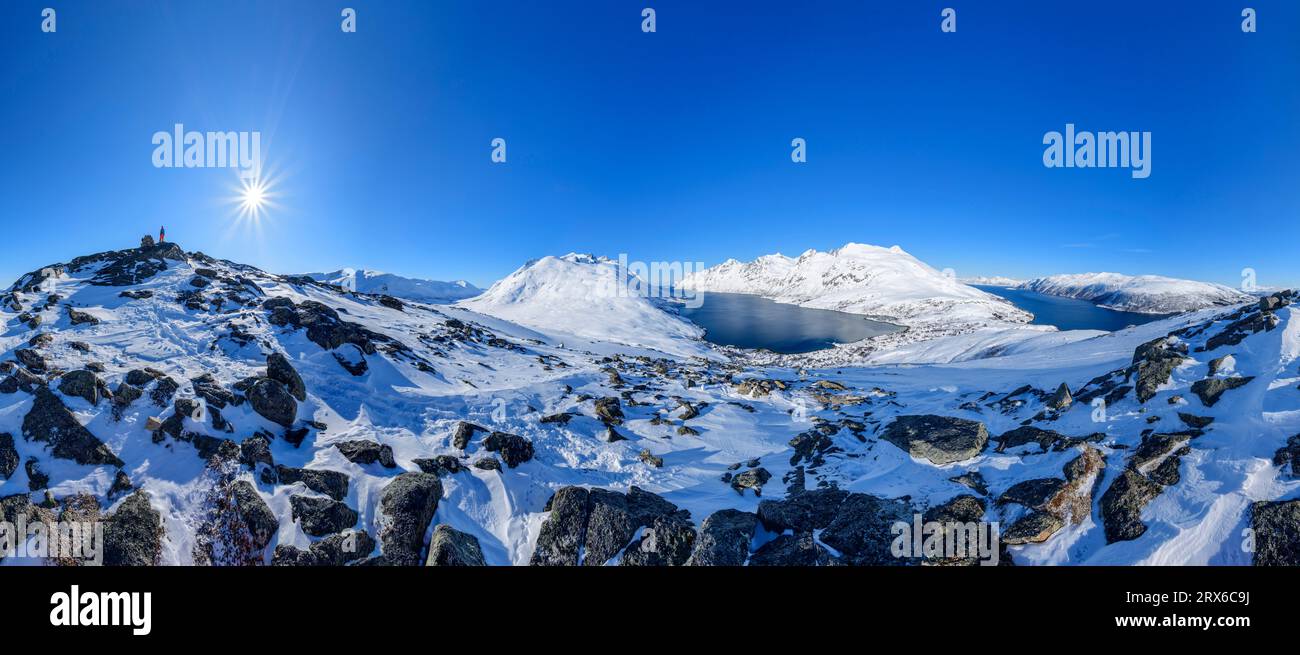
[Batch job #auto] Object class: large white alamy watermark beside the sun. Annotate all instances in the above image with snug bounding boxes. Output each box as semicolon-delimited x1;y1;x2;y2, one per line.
152;123;261;179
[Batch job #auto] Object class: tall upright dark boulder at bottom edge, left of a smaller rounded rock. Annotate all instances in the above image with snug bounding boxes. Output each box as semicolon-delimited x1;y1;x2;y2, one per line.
380;473;442;567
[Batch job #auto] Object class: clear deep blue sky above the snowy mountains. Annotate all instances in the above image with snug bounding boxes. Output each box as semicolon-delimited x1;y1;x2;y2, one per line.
0;0;1300;286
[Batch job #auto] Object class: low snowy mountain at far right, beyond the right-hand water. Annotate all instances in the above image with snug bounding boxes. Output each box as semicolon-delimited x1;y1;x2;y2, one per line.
1017;273;1255;315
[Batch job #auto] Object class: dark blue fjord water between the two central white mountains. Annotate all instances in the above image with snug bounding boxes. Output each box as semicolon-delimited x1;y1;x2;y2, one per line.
681;292;902;353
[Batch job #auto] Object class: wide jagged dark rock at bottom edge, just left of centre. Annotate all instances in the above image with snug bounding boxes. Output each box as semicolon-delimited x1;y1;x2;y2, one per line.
529;486;689;567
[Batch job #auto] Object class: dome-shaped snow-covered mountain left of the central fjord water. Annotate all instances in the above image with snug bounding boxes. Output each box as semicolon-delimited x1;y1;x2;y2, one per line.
460;253;706;355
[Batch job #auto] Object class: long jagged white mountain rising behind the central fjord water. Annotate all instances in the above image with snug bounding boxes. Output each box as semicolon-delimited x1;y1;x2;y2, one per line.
683;243;1032;333
